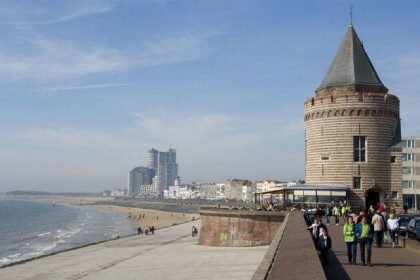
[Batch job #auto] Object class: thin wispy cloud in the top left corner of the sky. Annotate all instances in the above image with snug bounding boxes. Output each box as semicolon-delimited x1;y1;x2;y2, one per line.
0;0;117;25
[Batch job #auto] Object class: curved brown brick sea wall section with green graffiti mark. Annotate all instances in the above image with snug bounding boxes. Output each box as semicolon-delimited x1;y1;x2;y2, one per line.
198;208;286;247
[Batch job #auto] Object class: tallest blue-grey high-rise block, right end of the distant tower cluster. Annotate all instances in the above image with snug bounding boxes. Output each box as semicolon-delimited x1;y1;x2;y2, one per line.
154;149;178;197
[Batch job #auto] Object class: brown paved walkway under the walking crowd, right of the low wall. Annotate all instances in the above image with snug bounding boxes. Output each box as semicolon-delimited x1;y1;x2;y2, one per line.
324;219;420;280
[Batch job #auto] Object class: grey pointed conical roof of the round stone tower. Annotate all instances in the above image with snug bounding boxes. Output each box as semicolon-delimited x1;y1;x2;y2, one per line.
317;25;385;91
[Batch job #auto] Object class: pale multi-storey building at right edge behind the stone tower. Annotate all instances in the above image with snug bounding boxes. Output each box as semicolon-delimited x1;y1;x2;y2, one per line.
401;137;420;210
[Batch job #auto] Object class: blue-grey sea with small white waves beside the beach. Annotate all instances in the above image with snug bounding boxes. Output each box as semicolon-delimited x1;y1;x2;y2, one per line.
0;200;137;267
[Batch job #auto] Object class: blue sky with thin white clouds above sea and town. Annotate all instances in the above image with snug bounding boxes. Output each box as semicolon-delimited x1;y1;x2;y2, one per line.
0;0;420;192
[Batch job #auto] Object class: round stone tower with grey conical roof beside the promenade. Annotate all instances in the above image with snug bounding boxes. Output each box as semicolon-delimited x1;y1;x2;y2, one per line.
304;25;402;209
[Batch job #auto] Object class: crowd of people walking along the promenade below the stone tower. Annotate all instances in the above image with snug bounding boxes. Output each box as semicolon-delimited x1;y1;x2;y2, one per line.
308;205;399;266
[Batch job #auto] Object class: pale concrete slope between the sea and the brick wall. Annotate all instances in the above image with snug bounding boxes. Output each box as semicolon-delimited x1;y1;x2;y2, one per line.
0;220;268;280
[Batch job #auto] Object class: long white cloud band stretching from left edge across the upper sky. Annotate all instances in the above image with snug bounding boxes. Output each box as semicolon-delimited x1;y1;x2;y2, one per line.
0;33;217;82
